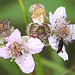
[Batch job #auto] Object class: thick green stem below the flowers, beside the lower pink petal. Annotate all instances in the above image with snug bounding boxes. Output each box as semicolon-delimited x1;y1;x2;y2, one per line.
34;54;44;75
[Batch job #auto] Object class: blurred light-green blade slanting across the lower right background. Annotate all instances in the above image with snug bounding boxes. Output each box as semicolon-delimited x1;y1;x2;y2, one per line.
41;58;75;75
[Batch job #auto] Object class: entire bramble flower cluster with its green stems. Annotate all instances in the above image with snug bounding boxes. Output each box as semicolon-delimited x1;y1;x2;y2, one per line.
0;0;75;75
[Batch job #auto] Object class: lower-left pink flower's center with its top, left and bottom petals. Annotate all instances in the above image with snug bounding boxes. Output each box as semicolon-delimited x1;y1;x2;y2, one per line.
0;29;34;73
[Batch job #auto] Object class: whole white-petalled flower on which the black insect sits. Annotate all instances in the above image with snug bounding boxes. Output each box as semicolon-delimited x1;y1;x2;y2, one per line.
48;7;75;61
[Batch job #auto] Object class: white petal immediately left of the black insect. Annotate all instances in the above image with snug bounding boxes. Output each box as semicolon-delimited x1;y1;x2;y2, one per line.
48;36;58;51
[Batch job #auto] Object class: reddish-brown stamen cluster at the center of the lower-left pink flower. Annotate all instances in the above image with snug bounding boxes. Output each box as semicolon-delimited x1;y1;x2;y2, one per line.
9;42;26;58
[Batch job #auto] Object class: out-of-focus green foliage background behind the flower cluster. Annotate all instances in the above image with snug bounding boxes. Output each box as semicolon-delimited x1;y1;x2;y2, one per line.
0;0;75;75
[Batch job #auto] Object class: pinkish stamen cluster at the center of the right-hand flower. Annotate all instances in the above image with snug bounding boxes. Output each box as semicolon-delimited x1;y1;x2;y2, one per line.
55;18;70;39
